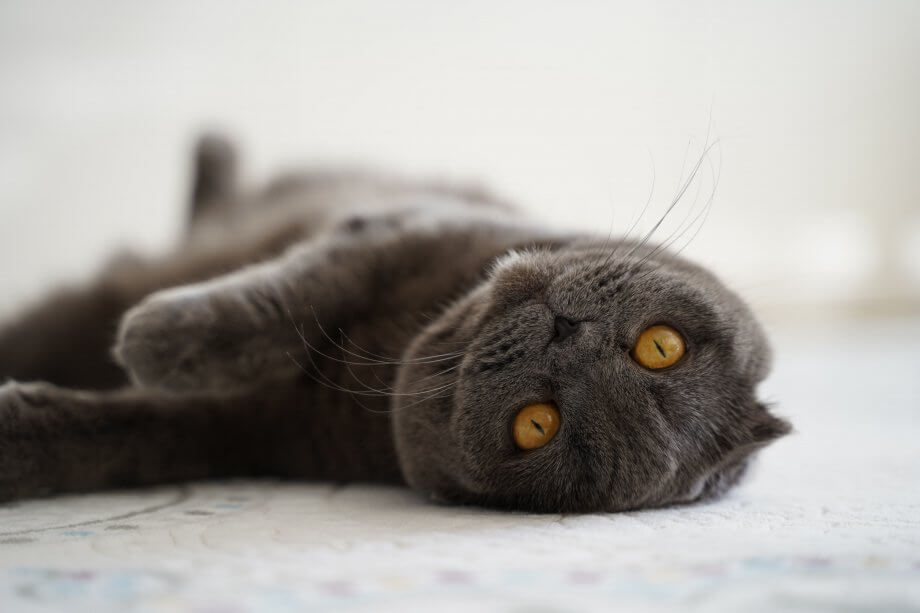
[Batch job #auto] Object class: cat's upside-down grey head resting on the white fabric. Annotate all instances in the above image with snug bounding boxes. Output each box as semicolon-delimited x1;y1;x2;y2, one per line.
394;243;789;511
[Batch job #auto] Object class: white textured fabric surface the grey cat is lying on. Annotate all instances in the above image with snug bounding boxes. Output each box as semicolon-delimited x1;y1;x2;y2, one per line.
0;321;920;613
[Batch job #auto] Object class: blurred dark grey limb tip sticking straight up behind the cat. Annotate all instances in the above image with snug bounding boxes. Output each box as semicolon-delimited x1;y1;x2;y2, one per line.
190;134;237;223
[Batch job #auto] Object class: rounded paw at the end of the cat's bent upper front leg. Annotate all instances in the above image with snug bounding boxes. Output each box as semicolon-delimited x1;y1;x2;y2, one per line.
113;293;210;390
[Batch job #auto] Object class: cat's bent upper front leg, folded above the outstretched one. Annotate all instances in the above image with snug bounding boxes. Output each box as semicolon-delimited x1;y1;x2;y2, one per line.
114;230;386;391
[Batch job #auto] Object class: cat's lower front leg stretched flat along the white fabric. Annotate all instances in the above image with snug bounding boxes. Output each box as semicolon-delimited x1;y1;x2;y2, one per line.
0;382;401;501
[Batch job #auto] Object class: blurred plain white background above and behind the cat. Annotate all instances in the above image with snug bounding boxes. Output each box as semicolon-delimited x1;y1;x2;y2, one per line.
0;0;920;320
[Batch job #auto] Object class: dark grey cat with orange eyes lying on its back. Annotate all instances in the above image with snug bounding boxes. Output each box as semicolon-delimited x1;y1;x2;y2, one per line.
0;137;790;512
